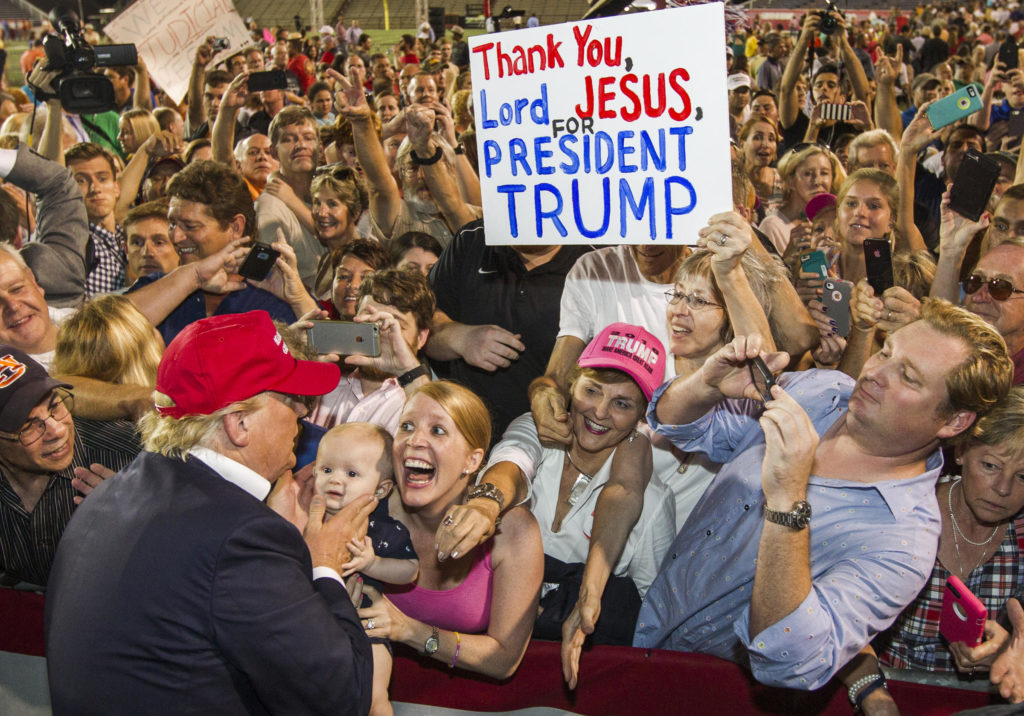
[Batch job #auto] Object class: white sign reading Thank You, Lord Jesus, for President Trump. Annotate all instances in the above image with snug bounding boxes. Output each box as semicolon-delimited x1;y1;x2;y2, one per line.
469;3;732;244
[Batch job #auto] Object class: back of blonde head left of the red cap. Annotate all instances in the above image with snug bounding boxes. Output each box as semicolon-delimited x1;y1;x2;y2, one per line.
53;294;164;385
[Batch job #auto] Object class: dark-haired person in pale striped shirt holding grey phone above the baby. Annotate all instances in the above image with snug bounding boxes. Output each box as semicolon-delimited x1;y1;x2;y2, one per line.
309;268;436;435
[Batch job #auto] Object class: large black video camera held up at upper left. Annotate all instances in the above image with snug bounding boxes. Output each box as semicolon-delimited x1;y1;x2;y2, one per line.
32;7;138;114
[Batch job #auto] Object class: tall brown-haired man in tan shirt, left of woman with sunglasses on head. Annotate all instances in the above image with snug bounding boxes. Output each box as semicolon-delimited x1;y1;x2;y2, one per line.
256;106;325;288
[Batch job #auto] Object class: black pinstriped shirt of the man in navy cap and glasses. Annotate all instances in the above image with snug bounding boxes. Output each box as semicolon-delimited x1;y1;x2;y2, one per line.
0;418;140;585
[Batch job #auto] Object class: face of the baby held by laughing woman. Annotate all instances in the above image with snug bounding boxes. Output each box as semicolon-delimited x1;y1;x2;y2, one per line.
314;435;383;514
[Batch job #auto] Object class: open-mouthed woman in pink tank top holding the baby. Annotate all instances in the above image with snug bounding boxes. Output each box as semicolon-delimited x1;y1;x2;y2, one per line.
359;381;544;678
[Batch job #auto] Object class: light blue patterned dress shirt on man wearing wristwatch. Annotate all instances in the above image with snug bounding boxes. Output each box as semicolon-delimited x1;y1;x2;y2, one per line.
634;370;942;689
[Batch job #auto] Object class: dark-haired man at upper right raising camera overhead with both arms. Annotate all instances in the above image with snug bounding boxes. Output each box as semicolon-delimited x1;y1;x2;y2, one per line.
778;2;869;146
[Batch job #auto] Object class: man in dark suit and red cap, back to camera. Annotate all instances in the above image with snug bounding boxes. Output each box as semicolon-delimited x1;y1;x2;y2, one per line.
46;311;376;714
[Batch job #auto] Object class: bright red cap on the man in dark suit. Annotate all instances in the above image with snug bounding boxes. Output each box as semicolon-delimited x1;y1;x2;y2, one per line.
157;310;341;418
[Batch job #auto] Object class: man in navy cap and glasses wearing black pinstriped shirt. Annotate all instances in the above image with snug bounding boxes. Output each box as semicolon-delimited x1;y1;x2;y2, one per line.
0;345;137;585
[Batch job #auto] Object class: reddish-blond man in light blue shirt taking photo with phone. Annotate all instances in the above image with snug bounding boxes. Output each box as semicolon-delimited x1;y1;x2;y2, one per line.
634;300;1013;689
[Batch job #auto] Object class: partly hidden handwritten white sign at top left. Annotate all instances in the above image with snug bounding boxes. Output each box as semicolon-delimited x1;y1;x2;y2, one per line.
103;0;252;102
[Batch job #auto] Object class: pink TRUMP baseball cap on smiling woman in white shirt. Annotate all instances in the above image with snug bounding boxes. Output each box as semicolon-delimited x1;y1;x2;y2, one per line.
577;323;666;401
